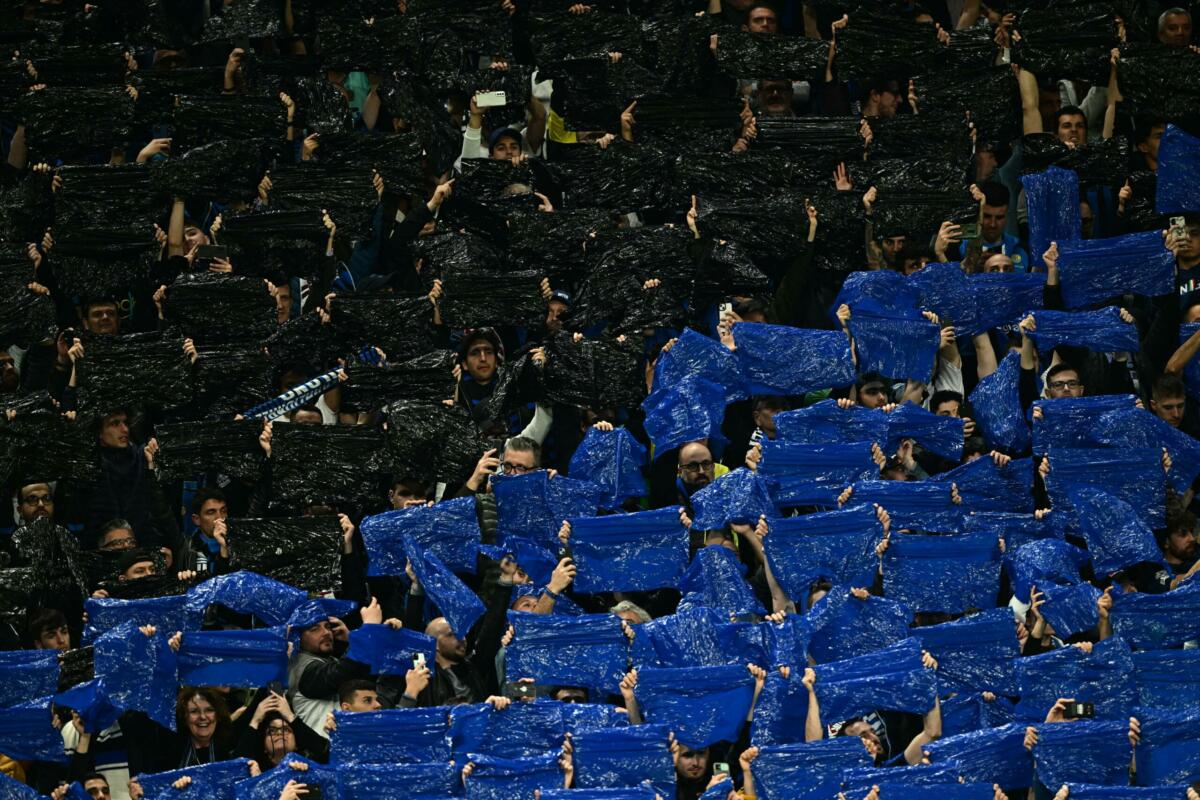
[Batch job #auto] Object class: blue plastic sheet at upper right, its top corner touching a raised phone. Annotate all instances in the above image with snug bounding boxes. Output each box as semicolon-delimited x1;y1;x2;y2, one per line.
1060;231;1175;309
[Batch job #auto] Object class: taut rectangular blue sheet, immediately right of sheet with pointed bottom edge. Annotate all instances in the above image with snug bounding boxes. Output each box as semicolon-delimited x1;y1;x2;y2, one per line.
883;531;1000;613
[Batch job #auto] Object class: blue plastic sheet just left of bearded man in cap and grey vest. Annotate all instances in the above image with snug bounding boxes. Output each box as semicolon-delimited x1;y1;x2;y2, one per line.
178;627;288;688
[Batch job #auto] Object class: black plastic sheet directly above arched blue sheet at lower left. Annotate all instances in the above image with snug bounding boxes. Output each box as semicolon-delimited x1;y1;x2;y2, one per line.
228;517;342;593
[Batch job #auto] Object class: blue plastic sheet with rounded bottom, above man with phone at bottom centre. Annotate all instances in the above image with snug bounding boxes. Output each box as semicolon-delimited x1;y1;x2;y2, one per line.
635;664;754;748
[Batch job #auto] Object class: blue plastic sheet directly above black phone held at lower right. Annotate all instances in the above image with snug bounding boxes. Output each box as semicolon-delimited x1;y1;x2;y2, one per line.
1014;638;1136;722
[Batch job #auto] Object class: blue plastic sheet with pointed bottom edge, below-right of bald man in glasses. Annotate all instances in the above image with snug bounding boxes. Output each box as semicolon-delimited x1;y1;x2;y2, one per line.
763;505;883;606
